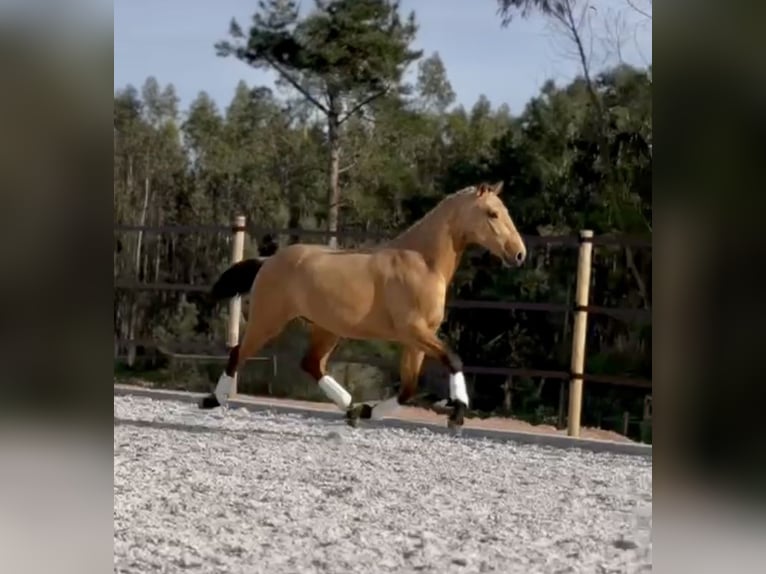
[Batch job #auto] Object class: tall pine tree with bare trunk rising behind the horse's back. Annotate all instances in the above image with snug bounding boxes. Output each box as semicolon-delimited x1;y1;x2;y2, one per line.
216;0;422;246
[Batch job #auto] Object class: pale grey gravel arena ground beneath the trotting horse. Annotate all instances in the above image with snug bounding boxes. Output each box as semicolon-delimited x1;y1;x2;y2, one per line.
114;397;652;574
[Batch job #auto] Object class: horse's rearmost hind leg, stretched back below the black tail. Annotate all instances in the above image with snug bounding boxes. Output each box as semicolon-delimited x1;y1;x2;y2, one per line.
199;304;289;409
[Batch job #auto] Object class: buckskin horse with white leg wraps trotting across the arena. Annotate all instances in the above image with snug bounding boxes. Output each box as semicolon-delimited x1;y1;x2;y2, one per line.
199;182;527;432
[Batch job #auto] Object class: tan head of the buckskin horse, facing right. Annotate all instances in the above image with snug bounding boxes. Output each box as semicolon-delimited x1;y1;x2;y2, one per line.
454;182;527;266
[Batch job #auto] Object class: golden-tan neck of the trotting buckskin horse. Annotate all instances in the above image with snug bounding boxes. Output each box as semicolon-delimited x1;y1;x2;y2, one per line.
389;212;465;284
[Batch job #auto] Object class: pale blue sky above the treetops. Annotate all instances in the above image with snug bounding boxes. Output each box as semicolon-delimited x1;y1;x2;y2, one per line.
114;0;652;115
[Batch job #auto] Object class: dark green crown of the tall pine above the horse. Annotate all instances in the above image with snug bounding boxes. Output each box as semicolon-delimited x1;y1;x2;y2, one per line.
216;0;421;95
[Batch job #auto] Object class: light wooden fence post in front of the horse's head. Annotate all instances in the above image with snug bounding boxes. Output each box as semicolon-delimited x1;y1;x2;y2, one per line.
567;229;593;437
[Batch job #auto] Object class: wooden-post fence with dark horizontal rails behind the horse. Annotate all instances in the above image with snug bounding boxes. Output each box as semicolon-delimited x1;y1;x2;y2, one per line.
114;216;652;437
